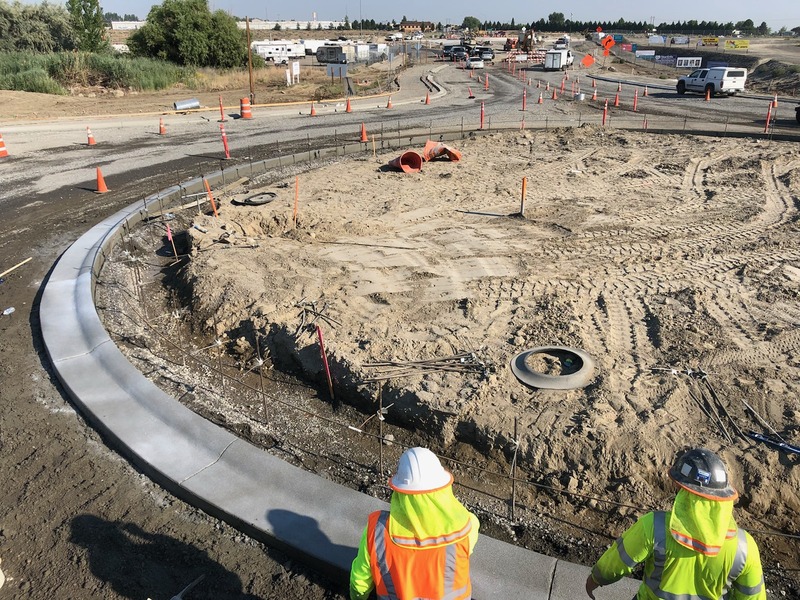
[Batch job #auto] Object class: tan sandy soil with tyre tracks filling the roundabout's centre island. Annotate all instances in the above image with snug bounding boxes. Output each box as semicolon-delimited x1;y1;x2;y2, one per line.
98;127;800;590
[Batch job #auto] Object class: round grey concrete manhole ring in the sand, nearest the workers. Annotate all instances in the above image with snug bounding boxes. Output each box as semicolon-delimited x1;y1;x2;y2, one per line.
511;346;594;390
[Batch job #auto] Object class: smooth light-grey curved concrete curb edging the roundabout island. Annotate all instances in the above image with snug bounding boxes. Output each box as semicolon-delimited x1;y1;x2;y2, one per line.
39;157;638;600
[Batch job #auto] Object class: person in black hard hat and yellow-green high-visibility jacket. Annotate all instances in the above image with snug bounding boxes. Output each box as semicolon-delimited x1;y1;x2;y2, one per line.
586;448;767;600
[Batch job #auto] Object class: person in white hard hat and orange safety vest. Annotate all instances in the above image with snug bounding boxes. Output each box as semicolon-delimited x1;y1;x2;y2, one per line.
350;448;479;600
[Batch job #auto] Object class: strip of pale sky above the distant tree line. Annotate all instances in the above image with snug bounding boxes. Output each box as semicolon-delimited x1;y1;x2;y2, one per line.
34;0;800;31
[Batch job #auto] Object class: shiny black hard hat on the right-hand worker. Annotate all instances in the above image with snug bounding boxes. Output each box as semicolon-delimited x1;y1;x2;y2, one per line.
669;448;739;500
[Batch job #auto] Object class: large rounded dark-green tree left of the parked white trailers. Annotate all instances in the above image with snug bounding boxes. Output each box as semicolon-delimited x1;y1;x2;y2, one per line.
128;0;247;68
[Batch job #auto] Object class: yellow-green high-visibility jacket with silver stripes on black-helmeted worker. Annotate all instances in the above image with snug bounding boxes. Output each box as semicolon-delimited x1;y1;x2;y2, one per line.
592;511;767;600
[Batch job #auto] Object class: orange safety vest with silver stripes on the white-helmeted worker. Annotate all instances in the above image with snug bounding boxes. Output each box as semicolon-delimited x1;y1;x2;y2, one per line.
367;511;472;600
